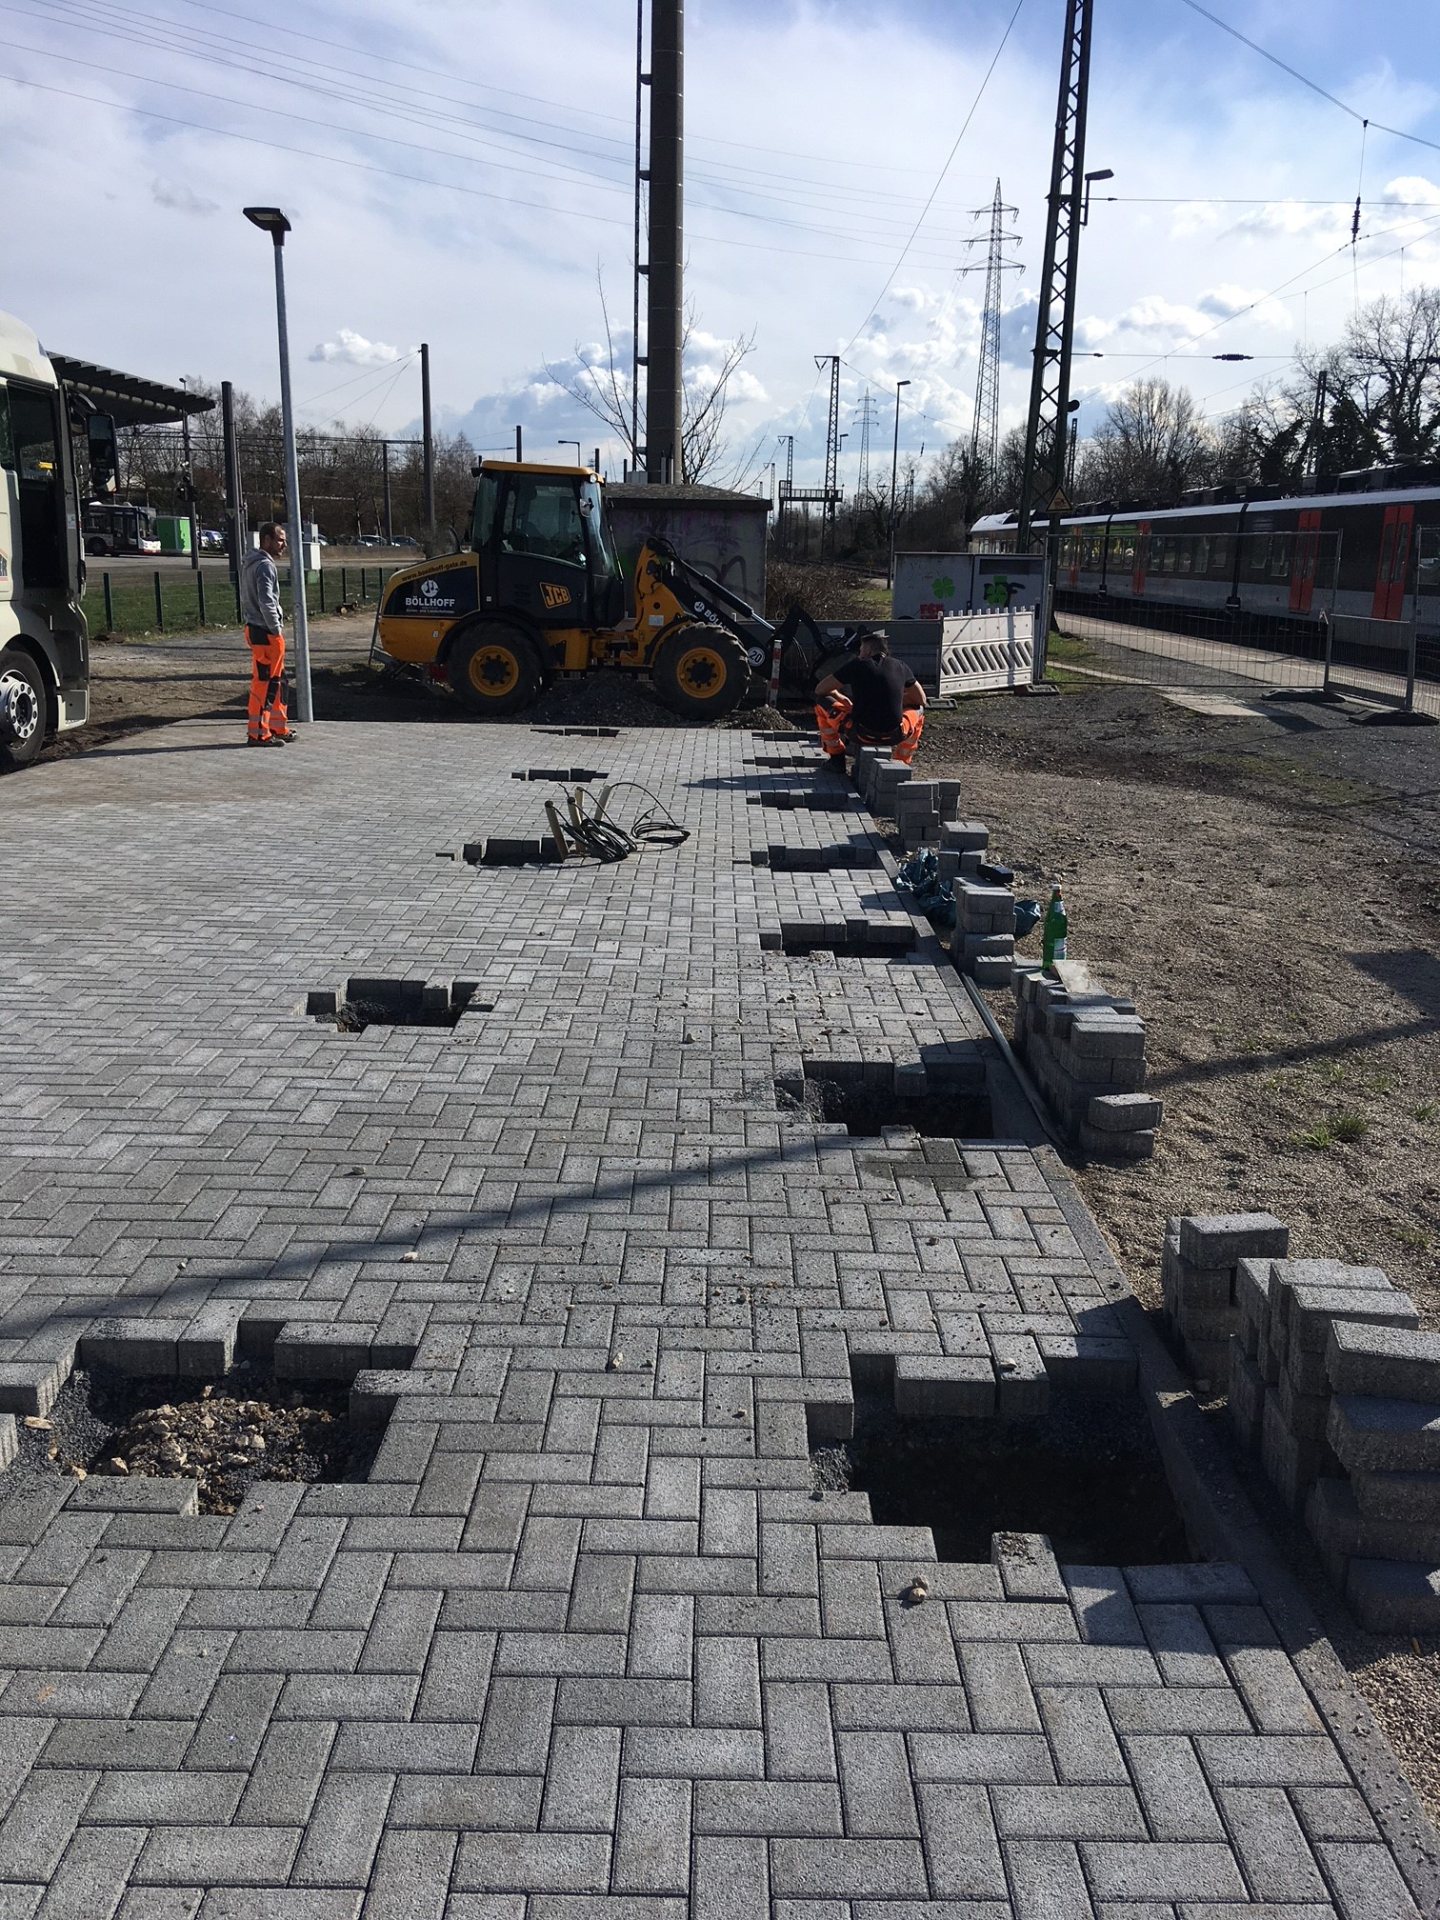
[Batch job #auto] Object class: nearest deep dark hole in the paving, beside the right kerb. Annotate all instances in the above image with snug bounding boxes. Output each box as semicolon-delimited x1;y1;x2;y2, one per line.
810;1392;1194;1567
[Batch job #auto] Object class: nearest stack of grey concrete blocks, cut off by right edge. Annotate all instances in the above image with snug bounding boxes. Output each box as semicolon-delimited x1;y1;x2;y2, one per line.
1231;1260;1440;1632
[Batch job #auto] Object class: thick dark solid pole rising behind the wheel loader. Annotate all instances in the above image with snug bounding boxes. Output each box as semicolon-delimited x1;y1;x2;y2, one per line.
645;0;685;486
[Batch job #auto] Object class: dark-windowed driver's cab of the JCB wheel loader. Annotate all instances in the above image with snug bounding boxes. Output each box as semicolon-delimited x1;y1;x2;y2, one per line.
470;461;626;630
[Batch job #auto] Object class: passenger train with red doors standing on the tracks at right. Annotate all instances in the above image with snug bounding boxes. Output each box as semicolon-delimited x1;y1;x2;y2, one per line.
970;467;1440;634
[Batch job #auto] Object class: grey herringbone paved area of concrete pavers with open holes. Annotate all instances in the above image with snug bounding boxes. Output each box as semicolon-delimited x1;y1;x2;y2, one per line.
0;722;1421;1920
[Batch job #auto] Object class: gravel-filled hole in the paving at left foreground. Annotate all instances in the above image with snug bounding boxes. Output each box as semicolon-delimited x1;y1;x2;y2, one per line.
6;1361;384;1513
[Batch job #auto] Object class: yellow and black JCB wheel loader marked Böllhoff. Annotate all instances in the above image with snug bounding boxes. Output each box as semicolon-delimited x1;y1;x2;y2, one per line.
376;461;776;720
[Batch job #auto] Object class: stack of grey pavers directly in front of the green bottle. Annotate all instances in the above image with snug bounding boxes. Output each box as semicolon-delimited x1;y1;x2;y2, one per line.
1012;960;1164;1160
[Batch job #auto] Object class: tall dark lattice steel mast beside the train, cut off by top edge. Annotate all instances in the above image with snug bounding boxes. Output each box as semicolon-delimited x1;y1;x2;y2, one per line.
1016;0;1094;553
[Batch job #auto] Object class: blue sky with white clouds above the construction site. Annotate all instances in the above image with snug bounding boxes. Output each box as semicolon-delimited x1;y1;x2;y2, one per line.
0;0;1440;484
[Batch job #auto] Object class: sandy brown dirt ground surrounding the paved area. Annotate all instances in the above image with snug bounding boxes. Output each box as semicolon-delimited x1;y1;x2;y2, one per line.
21;614;1440;1818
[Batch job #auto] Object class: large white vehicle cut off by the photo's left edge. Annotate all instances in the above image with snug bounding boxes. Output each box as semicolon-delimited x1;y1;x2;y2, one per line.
0;313;117;772
